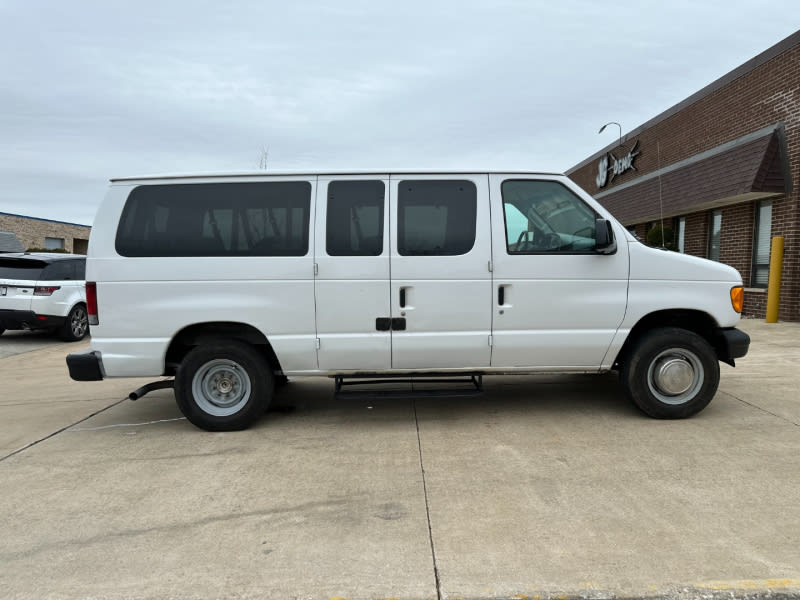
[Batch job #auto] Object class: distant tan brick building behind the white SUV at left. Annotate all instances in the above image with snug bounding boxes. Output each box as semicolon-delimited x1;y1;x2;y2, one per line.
0;212;92;254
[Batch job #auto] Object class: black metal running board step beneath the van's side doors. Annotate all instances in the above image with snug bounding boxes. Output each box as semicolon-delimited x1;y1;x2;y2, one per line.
334;373;483;400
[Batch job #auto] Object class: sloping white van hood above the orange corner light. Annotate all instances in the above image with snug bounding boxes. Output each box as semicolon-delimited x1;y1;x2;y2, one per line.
628;241;742;285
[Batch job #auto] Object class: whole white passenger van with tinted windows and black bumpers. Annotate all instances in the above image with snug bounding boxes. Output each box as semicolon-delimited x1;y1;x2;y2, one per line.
67;172;749;430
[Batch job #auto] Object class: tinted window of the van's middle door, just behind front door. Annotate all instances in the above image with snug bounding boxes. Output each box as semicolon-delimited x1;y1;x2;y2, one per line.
397;179;478;256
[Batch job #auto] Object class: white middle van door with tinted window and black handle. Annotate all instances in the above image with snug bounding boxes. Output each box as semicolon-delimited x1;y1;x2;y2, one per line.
390;174;492;370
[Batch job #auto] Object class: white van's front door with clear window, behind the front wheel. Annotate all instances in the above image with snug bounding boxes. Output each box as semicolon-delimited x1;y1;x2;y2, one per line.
489;175;628;370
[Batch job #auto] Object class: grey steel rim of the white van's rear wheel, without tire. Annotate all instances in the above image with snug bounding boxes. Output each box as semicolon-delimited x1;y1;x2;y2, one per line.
192;359;251;417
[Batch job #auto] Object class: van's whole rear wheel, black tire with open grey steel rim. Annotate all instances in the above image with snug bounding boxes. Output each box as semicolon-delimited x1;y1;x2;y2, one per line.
175;340;275;431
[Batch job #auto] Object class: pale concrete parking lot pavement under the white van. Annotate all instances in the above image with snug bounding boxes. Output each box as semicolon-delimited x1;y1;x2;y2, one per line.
0;320;800;599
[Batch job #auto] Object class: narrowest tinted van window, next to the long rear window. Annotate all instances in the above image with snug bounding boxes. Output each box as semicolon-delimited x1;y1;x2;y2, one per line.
325;181;386;256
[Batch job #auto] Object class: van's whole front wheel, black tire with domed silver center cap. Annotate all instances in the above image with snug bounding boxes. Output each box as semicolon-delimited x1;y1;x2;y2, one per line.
620;327;719;419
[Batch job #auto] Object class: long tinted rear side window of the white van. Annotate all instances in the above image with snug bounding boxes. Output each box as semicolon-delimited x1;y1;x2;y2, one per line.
116;181;311;257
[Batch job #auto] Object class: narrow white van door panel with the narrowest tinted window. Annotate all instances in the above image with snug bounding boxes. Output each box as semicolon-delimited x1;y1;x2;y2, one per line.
314;175;391;371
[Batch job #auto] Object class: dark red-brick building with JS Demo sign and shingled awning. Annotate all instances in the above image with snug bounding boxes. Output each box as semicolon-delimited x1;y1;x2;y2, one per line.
567;31;800;321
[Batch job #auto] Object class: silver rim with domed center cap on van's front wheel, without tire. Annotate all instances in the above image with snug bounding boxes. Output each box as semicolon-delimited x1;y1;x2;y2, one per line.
647;348;704;404
